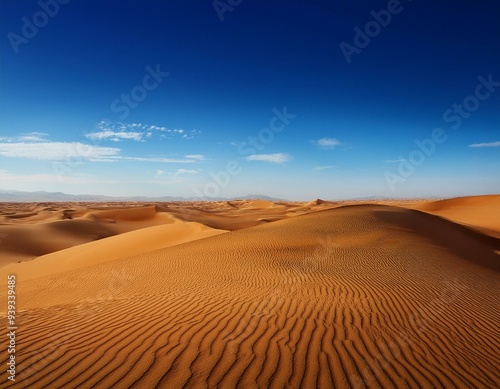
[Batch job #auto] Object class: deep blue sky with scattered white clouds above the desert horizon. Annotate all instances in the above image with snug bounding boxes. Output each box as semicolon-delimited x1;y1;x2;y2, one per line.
0;0;500;200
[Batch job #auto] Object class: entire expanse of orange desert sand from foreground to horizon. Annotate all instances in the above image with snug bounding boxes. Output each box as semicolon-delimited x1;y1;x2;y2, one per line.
0;195;500;388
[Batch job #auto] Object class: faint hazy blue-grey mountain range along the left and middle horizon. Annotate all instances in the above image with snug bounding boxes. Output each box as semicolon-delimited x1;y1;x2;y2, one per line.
0;189;282;203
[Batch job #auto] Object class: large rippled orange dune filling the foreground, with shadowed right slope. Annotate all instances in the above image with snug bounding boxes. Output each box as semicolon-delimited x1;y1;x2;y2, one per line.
0;205;500;388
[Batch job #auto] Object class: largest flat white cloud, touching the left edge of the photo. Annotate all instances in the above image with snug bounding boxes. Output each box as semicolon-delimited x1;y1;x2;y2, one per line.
0;141;120;161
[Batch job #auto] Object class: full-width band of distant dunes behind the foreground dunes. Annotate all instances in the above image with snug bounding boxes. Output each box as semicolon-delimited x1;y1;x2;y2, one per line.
0;195;500;267
